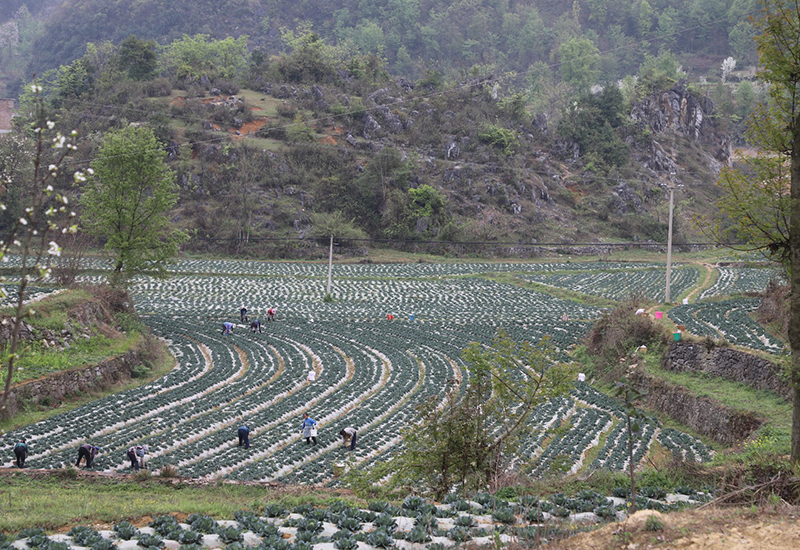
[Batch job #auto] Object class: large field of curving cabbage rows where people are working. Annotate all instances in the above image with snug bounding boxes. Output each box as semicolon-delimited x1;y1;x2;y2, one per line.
0;262;724;483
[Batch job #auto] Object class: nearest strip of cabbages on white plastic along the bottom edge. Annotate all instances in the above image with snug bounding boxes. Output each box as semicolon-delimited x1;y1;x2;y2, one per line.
0;494;707;550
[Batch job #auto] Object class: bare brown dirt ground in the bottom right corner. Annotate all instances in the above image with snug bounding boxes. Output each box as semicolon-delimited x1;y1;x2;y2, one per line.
549;506;800;550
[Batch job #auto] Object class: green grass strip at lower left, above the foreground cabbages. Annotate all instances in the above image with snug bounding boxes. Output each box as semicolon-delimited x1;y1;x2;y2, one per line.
0;470;360;534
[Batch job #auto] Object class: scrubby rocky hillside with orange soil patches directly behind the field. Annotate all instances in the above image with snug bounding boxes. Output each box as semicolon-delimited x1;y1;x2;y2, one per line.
0;33;744;258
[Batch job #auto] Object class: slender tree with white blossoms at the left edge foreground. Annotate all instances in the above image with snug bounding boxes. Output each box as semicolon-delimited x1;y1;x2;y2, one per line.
0;83;80;417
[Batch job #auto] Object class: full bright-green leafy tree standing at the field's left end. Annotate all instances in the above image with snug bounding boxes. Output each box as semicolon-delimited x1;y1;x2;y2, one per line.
81;126;188;282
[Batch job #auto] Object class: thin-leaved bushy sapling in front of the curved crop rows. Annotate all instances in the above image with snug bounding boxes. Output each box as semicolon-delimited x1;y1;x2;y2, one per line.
351;329;575;499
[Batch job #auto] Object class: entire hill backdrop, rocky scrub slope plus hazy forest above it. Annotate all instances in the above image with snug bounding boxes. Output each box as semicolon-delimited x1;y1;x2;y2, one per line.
0;0;763;256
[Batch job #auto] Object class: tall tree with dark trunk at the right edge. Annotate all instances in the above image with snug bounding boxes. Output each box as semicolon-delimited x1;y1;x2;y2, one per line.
713;0;800;463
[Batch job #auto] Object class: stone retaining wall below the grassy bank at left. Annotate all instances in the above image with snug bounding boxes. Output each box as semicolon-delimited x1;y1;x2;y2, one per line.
3;350;142;417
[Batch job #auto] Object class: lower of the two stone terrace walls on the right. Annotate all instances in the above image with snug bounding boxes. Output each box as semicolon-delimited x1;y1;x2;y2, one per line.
633;373;763;446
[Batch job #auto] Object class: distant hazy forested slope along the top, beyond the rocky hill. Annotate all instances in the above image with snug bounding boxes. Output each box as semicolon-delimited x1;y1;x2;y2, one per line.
0;0;757;96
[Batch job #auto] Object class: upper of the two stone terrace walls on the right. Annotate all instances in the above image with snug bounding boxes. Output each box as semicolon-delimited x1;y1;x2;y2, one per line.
662;342;792;401
